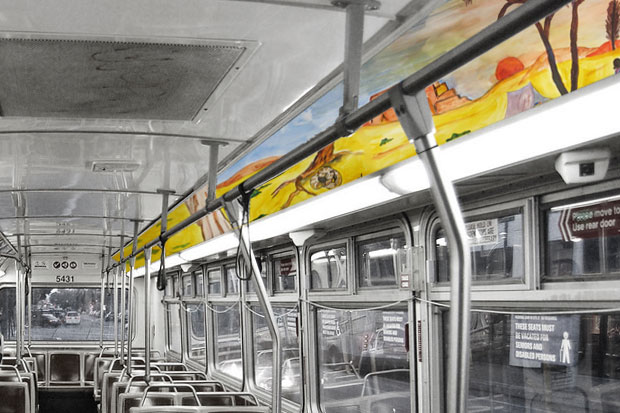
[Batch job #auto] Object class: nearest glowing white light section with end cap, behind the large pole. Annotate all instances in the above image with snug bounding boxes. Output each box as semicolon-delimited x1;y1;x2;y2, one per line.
383;76;620;194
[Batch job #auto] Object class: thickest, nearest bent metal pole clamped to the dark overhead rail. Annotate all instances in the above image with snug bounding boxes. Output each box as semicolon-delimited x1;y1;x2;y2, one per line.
389;87;471;413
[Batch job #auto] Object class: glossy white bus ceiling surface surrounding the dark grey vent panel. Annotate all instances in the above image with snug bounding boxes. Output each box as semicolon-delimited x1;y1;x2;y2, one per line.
0;0;409;253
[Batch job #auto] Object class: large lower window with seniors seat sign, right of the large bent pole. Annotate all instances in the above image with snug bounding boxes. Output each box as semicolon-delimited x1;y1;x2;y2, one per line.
444;313;620;413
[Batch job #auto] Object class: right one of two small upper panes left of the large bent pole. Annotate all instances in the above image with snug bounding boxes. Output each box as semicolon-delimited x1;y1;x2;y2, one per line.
357;234;406;287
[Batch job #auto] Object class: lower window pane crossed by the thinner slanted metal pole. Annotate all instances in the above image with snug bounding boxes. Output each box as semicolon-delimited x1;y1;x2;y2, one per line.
252;306;302;403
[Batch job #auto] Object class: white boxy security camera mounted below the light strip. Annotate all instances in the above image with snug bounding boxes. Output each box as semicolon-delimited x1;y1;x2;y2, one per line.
555;148;611;184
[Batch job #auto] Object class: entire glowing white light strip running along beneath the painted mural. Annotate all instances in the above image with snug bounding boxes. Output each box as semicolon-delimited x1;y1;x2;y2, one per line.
134;76;620;268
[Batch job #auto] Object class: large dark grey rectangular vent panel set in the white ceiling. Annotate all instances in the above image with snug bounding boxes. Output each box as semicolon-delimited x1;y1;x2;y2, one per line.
0;38;246;121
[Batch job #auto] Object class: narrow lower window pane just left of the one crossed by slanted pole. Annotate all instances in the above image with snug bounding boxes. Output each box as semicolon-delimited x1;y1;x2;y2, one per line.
213;304;243;380
